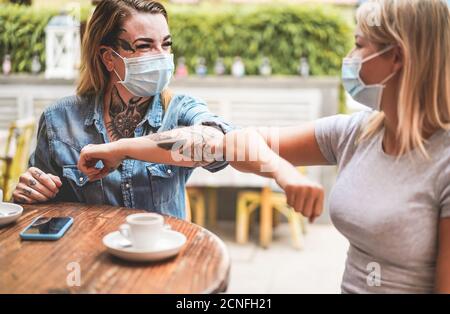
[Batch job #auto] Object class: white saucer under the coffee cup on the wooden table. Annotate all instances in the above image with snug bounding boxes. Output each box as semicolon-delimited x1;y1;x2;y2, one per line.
103;230;186;262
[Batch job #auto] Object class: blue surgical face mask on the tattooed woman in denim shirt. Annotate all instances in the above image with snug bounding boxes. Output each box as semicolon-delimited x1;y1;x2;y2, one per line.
112;50;175;97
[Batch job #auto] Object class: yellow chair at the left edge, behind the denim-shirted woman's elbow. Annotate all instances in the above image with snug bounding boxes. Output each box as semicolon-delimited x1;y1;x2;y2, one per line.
0;118;35;200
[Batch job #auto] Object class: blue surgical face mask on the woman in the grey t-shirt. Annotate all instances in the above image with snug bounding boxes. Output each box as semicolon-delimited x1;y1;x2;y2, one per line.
342;46;397;111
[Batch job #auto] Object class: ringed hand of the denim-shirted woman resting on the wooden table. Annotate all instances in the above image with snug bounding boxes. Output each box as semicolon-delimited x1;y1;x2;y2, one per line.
13;167;62;204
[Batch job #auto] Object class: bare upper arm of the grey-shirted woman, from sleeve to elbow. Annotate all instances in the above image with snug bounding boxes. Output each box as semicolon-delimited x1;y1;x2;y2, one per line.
257;122;329;166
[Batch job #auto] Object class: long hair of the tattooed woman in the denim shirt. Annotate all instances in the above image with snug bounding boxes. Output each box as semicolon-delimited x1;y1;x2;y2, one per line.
77;0;172;110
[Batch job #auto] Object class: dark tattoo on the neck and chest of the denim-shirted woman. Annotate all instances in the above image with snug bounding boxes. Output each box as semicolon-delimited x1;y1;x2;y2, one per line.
106;87;152;141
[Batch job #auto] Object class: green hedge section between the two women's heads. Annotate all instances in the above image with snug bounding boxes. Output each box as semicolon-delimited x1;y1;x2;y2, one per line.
170;6;351;75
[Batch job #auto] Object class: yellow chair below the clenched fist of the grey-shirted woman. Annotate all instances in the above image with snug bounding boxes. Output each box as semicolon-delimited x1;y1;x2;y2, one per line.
236;168;306;249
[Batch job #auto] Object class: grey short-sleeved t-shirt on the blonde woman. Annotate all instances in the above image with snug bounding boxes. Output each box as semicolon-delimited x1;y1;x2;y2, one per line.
315;111;450;293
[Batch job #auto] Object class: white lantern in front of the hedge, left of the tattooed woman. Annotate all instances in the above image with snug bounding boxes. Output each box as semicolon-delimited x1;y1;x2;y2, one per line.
45;13;80;79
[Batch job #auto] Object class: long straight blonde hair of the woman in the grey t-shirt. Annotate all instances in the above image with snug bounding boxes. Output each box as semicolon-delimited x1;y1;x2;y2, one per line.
357;0;450;158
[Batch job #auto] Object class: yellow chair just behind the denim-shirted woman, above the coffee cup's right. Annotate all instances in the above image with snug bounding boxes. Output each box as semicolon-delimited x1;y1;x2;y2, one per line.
187;187;217;227
